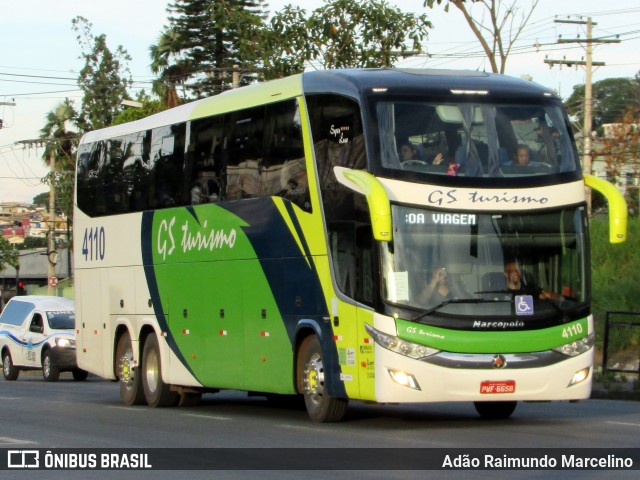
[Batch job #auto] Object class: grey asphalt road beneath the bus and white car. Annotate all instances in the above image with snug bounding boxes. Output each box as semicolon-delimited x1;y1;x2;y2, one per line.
0;372;640;480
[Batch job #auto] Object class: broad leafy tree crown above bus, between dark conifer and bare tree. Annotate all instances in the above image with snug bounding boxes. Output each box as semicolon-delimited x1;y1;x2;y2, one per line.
265;0;432;77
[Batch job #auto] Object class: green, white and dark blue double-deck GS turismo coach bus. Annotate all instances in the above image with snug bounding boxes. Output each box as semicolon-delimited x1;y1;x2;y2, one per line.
74;69;626;422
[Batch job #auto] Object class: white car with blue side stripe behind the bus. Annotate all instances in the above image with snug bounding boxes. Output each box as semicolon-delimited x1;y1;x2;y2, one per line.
0;296;87;382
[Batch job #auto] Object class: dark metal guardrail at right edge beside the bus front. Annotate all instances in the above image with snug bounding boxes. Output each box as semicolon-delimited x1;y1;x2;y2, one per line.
602;311;640;375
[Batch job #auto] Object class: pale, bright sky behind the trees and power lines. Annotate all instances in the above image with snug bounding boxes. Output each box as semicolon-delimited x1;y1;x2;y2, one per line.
0;0;640;203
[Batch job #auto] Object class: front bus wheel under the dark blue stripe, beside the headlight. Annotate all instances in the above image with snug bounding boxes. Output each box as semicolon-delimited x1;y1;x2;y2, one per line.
296;335;348;422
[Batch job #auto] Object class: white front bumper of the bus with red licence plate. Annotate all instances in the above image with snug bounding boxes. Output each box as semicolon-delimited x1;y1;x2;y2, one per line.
375;344;593;403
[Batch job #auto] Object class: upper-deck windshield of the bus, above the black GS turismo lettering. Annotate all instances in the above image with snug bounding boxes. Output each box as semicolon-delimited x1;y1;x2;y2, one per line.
372;98;579;177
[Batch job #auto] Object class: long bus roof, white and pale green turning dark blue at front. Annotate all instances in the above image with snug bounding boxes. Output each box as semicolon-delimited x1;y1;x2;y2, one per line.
80;68;556;143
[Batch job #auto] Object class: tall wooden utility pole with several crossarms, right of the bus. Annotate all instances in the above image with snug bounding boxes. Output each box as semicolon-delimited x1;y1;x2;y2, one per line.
544;17;620;214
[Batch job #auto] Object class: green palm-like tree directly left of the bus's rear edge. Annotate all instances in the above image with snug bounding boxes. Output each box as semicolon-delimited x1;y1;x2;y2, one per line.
40;98;78;225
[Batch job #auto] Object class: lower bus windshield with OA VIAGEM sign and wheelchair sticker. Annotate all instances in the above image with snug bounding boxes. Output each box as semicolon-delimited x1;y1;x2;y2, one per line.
382;205;587;316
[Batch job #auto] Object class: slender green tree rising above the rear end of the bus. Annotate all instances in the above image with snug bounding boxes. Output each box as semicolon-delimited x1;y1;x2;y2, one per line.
71;16;132;131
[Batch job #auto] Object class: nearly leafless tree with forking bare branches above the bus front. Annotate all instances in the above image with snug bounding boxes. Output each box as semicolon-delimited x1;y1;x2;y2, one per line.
424;0;538;73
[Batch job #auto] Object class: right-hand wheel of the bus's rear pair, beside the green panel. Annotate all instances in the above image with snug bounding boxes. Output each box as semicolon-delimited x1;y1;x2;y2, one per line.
142;335;180;407
